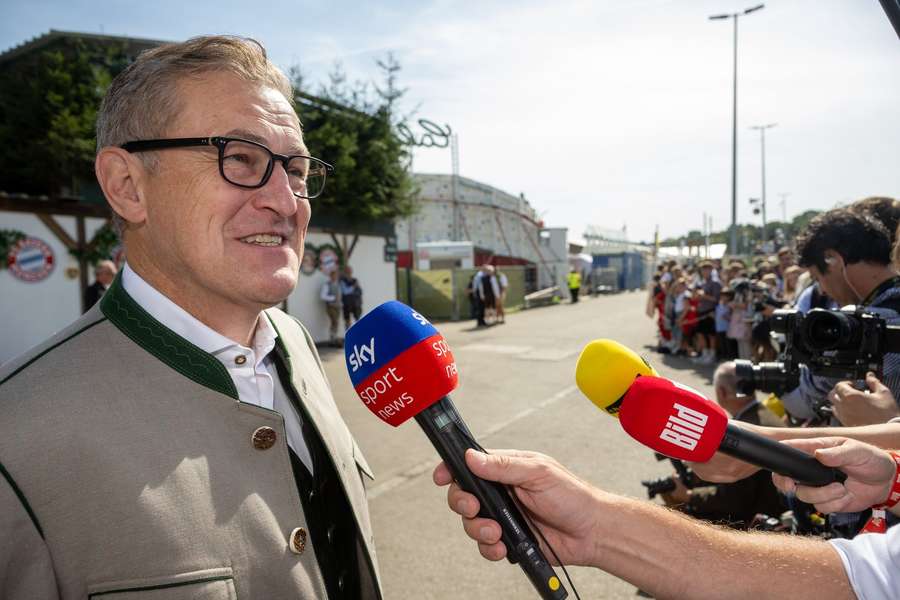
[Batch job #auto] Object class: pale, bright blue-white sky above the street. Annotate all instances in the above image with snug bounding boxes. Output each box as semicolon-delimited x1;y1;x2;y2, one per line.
0;0;900;240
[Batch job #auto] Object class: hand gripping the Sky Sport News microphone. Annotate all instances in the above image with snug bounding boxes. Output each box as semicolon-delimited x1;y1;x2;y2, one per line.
433;449;603;565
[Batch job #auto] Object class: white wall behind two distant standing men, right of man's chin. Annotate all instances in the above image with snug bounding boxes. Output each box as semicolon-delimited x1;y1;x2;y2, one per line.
288;232;397;341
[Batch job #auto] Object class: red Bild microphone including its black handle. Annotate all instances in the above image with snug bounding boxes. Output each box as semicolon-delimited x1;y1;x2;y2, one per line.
619;376;847;487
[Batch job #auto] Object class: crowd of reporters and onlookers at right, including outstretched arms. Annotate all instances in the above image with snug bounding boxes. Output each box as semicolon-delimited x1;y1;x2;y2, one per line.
434;198;900;599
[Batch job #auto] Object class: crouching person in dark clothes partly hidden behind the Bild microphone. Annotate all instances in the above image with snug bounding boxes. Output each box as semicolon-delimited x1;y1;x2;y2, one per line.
666;362;786;529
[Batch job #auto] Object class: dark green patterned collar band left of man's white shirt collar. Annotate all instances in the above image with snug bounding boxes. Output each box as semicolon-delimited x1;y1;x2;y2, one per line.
100;272;239;400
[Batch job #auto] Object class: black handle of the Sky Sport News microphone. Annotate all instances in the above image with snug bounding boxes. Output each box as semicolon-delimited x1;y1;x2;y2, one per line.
416;396;569;600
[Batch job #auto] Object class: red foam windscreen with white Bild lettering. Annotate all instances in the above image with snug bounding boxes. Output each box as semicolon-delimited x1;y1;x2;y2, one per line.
619;376;728;462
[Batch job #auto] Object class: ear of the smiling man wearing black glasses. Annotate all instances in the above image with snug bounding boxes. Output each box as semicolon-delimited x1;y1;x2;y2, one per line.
94;146;147;224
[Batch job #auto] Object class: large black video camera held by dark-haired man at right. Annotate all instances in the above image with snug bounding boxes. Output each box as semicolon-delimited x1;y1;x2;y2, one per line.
735;307;900;395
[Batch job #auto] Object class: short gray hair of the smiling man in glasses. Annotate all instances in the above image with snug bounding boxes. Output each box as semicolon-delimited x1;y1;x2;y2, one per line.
97;35;294;238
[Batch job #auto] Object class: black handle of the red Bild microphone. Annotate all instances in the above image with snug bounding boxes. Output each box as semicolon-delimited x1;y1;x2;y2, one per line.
719;423;847;487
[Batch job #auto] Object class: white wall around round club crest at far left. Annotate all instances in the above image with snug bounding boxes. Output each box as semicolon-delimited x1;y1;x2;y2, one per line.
0;211;104;364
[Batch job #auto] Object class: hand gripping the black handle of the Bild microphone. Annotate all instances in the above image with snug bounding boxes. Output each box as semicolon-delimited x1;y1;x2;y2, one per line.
772;437;897;513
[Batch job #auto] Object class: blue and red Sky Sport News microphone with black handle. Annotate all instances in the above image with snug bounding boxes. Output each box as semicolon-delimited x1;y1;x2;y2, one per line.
344;301;568;600
